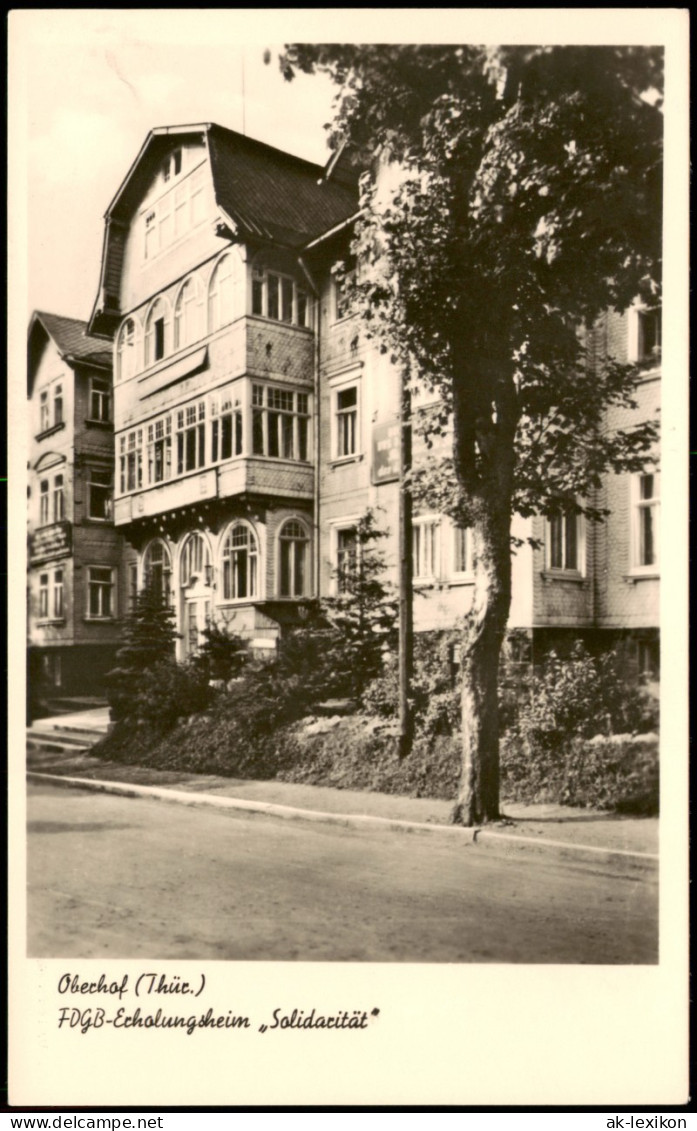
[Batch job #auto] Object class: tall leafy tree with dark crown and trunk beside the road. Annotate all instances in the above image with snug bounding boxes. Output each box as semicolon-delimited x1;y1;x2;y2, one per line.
281;44;662;824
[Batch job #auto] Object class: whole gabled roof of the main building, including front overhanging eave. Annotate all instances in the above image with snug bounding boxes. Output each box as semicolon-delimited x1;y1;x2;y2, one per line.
89;122;358;334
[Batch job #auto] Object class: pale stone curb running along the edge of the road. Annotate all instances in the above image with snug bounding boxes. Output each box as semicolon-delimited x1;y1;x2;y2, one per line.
27;770;659;872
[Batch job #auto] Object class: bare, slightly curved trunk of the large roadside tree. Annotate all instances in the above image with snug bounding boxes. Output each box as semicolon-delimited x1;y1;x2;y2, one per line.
453;498;511;826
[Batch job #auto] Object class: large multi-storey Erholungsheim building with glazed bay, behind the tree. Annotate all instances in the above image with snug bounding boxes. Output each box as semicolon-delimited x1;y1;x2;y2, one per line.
76;123;660;674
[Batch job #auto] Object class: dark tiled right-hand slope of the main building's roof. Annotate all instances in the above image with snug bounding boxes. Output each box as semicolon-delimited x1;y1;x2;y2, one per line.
203;126;358;247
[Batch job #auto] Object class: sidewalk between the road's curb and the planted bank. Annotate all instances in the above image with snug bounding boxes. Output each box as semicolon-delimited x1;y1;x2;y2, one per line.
27;711;659;866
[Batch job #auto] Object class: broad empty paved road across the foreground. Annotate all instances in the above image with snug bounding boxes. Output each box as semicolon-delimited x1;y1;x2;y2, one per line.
28;784;657;964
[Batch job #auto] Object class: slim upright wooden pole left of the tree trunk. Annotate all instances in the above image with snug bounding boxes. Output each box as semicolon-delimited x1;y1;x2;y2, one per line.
398;374;414;758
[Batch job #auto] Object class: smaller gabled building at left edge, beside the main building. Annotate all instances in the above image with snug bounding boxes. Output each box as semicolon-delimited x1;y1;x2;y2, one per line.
27;311;121;698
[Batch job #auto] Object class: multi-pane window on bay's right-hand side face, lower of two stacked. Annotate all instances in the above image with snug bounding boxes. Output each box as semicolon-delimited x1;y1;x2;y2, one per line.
251;385;310;460
